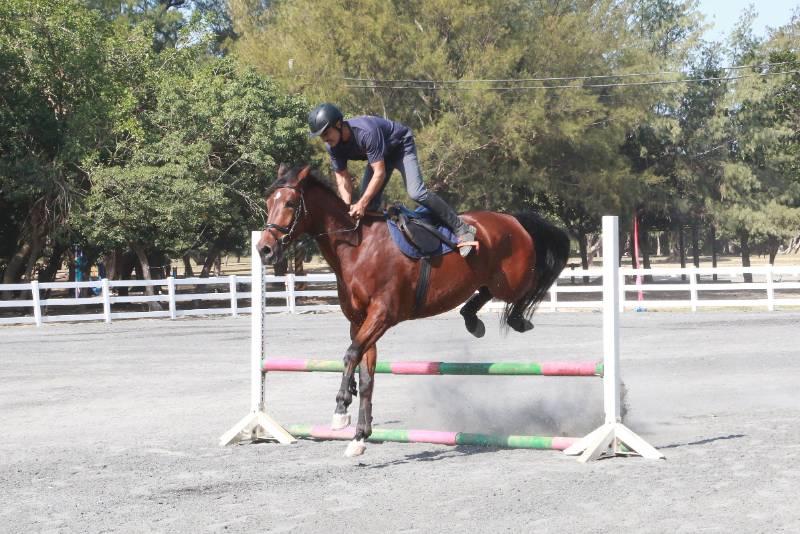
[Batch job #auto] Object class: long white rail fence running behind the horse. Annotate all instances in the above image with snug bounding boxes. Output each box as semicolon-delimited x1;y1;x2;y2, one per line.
0;266;800;325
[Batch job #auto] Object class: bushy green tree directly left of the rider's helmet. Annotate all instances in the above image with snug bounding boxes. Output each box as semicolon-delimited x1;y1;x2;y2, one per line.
79;55;309;255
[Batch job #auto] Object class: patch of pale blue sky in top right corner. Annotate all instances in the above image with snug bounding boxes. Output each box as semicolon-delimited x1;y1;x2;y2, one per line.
699;0;800;41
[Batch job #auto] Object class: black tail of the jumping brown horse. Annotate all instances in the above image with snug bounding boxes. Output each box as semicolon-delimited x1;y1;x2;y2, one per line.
503;212;569;324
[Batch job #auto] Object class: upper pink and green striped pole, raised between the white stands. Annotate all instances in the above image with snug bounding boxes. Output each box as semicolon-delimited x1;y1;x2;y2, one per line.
261;359;603;376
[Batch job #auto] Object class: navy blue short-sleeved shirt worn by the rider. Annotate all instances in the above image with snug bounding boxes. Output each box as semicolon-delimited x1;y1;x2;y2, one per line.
325;115;413;171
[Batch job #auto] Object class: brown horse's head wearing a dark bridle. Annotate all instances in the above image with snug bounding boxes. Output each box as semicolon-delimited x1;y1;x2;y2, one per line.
257;164;311;265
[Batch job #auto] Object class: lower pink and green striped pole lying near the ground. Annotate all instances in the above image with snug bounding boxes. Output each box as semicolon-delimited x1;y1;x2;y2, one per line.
286;425;578;451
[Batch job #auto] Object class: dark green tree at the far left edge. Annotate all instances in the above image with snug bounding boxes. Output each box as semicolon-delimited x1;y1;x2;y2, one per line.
0;0;113;283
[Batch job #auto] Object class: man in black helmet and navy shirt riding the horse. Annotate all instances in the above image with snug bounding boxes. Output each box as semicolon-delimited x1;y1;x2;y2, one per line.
308;103;476;256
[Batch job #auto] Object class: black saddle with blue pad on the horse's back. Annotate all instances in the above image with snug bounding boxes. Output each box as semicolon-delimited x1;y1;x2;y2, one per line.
386;204;458;258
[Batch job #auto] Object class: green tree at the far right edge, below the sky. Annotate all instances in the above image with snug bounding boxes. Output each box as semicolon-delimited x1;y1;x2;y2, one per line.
709;12;800;280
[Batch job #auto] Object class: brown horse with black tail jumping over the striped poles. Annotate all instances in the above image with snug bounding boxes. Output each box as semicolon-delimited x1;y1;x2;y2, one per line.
258;165;569;456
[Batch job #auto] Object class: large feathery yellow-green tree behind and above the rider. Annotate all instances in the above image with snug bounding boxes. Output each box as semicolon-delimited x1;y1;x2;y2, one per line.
227;0;694;254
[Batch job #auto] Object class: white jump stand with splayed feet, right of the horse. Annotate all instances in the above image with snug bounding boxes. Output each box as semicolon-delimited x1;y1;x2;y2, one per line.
564;216;664;462
